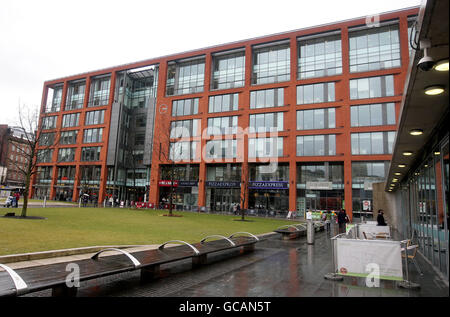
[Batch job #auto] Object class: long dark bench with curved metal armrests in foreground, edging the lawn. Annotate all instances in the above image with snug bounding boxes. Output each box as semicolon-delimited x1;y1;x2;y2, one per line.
0;232;260;297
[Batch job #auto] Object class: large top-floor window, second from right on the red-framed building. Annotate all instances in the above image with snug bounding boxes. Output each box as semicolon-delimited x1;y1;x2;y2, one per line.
297;34;342;79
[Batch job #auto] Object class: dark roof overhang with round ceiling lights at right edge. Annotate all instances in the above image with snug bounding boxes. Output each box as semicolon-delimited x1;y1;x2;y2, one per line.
385;0;449;191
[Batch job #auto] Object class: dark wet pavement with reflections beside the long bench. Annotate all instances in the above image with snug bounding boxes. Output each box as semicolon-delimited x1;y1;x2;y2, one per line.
22;222;449;297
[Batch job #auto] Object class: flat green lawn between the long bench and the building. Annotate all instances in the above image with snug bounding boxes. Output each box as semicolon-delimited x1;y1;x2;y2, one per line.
0;207;298;255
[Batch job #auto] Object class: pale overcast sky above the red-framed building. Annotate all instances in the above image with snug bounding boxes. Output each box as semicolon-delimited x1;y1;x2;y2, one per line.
0;0;421;125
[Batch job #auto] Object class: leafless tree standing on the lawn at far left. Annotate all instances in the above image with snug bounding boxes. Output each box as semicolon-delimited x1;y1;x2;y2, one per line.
8;105;58;217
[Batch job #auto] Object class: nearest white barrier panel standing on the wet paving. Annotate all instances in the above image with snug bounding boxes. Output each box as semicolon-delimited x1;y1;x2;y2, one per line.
335;238;403;281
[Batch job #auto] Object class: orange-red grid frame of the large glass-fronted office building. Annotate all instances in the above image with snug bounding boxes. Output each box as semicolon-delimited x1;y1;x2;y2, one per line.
31;8;418;220
